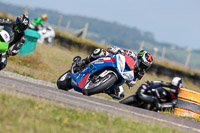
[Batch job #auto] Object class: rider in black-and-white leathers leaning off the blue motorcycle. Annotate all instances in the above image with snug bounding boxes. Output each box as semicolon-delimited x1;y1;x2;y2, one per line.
76;46;153;100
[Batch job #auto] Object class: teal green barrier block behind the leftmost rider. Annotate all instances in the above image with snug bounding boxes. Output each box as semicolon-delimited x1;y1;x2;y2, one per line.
18;29;40;55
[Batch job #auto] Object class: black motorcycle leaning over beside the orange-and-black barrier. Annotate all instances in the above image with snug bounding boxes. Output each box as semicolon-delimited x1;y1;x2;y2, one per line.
119;84;177;112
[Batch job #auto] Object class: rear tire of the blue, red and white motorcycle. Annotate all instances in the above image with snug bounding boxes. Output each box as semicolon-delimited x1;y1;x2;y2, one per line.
57;71;72;91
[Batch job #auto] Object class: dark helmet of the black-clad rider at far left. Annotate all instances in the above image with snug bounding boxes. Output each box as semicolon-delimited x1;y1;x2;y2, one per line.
14;14;29;33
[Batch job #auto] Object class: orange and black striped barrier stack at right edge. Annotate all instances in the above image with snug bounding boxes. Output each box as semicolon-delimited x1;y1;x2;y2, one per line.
174;88;200;118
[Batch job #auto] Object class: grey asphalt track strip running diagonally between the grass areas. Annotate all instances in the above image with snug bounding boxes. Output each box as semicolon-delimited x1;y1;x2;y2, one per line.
0;72;200;133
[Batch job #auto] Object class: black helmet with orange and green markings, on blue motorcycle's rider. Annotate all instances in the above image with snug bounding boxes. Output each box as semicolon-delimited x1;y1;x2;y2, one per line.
136;50;153;71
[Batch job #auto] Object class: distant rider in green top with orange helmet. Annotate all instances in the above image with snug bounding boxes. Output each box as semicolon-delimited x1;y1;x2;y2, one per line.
29;14;48;30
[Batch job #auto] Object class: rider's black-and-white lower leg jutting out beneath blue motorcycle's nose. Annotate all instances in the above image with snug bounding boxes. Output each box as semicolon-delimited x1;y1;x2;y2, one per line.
108;86;124;100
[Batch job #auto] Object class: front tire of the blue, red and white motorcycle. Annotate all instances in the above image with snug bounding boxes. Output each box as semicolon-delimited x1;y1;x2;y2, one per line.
82;73;117;96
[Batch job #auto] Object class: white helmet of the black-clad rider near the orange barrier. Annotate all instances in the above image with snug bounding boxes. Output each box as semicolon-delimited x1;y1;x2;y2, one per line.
170;77;183;93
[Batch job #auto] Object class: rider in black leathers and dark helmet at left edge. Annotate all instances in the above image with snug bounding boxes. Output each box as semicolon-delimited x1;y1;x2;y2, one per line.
0;14;29;70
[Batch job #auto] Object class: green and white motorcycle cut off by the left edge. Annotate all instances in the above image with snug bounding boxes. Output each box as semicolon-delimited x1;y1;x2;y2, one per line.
0;25;14;68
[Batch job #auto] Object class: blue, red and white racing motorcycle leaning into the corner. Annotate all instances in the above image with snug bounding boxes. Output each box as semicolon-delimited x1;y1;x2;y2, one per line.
57;54;135;96
